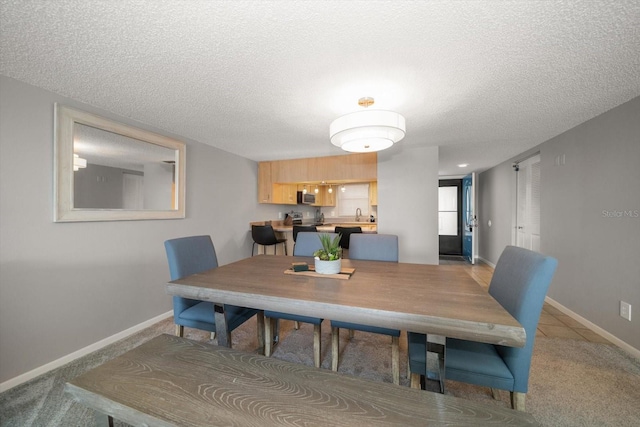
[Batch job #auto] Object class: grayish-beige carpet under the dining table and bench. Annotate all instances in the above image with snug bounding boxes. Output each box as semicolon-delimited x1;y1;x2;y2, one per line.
0;319;640;427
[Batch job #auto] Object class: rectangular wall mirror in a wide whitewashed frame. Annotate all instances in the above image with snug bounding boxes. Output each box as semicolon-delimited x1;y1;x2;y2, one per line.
54;104;186;222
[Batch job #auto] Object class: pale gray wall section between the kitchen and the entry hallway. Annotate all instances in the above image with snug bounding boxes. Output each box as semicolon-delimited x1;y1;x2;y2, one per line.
378;142;438;264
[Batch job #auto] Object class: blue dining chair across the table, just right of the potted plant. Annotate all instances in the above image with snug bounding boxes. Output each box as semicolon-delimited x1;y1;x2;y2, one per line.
331;236;400;384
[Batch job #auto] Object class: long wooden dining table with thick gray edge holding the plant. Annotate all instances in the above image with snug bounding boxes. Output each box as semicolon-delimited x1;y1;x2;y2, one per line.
167;255;526;347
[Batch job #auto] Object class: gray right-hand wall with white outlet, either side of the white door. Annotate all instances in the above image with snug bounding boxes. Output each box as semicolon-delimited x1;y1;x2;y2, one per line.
479;97;640;349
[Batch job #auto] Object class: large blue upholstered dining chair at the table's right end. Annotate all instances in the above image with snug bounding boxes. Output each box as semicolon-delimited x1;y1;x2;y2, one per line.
408;246;558;411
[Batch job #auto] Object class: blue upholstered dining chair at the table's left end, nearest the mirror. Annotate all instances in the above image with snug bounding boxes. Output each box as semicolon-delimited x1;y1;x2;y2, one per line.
164;236;264;347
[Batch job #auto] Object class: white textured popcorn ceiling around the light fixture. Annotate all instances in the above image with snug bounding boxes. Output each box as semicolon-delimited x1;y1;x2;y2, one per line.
0;0;640;175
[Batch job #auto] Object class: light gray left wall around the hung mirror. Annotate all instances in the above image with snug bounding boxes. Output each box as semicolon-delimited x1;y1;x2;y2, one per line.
0;76;282;383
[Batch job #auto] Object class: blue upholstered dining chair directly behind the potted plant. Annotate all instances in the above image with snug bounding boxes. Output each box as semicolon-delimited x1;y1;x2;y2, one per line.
264;231;336;368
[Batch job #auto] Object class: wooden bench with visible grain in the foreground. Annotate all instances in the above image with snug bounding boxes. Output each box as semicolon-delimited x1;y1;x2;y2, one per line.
65;335;536;427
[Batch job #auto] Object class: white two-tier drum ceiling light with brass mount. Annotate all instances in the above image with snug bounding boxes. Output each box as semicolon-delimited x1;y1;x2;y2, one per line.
329;97;406;153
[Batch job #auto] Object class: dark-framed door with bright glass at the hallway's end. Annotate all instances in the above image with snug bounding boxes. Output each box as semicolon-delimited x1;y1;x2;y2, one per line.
438;179;462;257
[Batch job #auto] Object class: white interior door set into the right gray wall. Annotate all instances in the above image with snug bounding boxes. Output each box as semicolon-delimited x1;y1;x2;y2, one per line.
515;154;540;252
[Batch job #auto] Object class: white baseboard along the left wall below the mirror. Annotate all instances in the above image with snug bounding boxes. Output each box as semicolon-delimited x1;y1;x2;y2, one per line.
0;310;173;393
